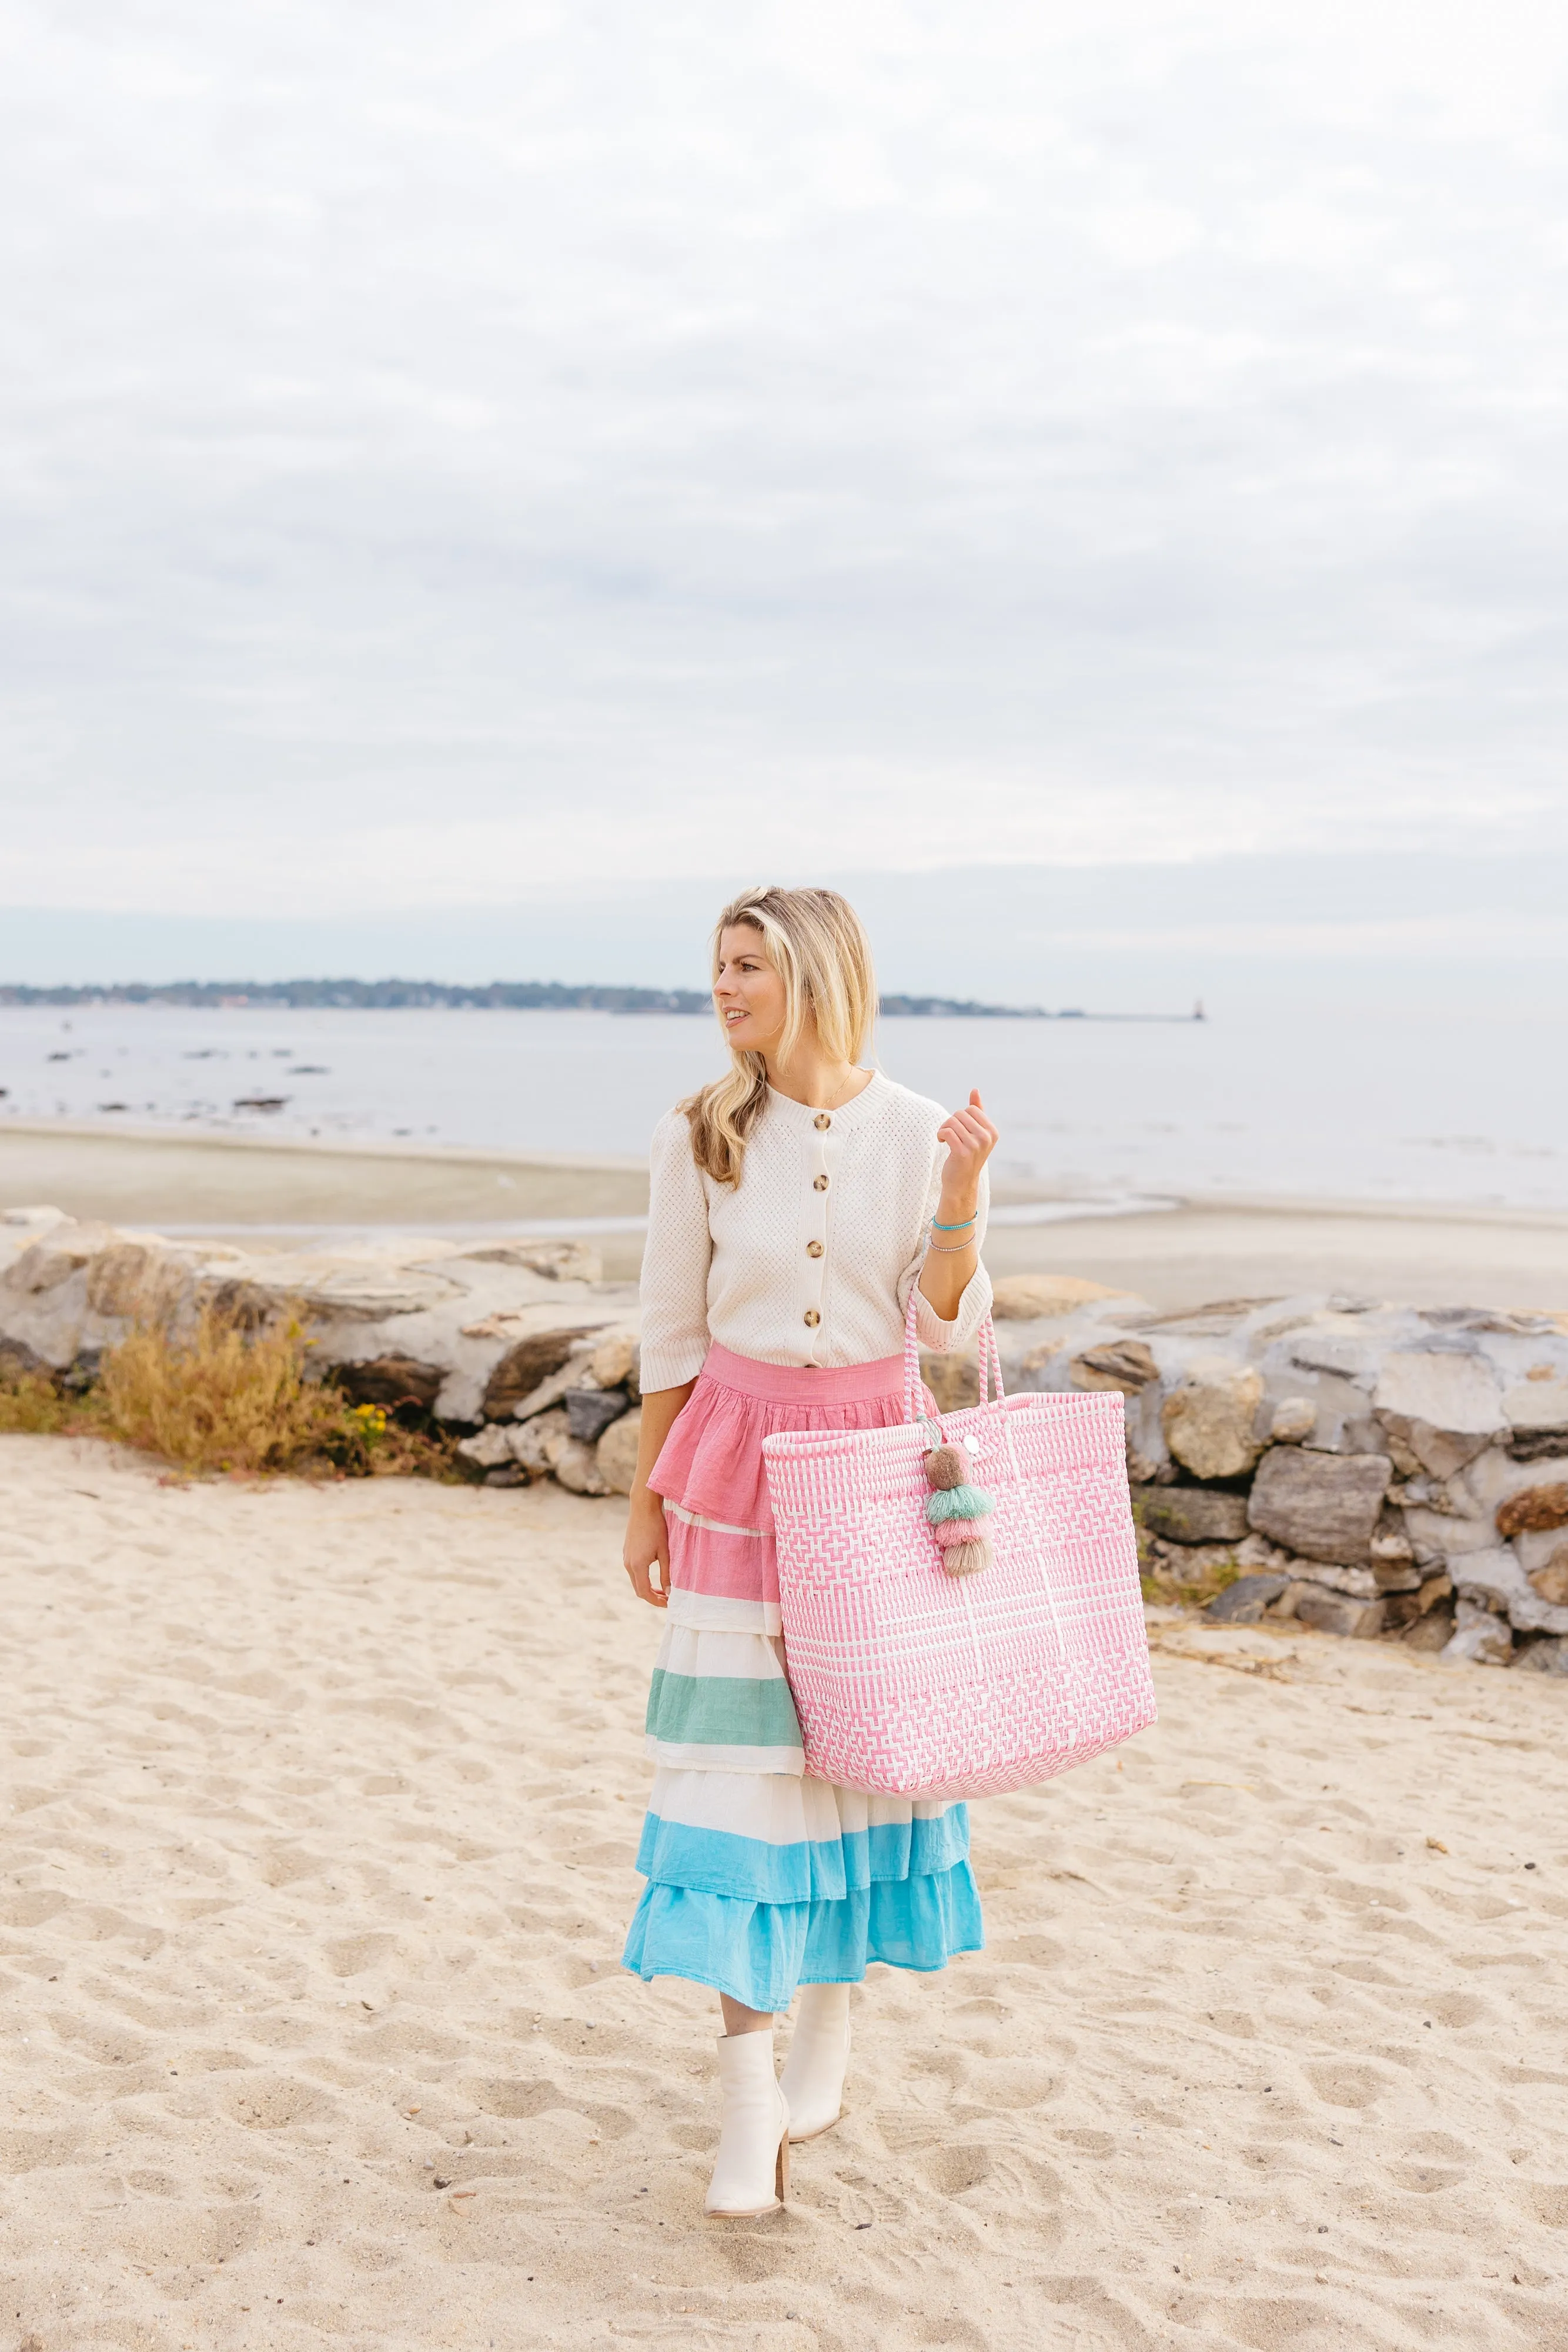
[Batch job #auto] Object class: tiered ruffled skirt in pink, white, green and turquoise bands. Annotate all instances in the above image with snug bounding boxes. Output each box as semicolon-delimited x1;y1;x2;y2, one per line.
623;1345;985;2011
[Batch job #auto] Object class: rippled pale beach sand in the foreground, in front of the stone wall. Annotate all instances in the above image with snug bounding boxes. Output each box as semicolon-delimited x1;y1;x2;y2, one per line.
0;1437;1568;2352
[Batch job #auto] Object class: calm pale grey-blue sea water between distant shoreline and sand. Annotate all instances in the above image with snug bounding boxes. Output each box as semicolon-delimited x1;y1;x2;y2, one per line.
0;1002;1568;1209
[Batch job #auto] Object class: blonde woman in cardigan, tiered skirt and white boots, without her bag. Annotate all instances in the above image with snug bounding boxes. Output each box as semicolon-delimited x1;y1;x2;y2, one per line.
626;889;997;2216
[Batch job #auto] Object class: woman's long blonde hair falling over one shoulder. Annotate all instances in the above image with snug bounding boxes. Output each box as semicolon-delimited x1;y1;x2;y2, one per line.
680;887;877;1183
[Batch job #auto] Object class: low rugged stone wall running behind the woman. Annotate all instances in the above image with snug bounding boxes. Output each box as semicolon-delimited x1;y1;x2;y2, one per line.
0;1209;1568;1672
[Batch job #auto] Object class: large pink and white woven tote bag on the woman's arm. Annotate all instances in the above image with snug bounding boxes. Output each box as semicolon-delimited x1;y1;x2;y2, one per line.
762;1298;1154;1797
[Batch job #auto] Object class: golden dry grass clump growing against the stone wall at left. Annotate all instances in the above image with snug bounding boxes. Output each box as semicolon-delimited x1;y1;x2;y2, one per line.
0;1308;461;1477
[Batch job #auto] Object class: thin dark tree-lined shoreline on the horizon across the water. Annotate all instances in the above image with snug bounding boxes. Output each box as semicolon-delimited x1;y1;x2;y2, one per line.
0;981;1206;1021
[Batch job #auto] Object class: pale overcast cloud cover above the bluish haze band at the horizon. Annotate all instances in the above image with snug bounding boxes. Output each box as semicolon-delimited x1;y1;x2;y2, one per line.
0;0;1568;955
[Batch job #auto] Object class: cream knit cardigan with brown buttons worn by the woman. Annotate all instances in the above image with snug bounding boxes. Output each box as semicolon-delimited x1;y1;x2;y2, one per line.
640;1073;992;1390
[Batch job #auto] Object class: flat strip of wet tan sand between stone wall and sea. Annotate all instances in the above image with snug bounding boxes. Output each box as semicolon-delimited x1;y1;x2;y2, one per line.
0;1122;1568;1312
